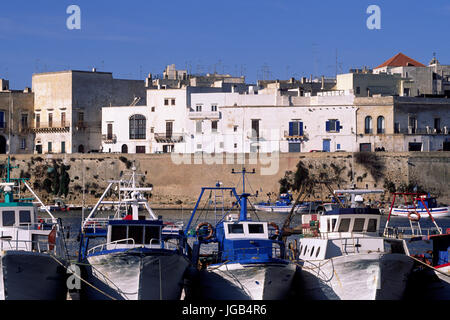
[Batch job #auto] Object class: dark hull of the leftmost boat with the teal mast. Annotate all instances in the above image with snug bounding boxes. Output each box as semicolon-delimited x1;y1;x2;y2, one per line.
0;251;67;300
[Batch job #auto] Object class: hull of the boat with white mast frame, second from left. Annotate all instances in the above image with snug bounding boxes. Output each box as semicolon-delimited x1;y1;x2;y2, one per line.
82;253;189;300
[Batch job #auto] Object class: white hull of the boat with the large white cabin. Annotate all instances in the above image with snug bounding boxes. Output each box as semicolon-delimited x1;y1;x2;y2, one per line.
301;253;413;300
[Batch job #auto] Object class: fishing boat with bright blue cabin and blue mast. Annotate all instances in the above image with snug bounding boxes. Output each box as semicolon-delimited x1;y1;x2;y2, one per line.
185;169;296;300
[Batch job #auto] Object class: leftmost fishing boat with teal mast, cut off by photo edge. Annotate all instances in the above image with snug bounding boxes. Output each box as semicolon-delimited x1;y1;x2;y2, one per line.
0;157;68;300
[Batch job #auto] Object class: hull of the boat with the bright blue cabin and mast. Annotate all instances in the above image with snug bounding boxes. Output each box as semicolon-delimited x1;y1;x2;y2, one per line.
189;263;296;300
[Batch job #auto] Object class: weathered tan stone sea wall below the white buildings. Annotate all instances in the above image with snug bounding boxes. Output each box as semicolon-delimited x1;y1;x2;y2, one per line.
0;152;450;208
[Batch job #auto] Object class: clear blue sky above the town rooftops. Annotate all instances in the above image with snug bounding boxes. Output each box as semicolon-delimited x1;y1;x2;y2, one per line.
0;0;450;89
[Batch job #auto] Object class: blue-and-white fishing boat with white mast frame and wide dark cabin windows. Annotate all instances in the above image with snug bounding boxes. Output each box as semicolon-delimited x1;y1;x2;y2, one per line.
79;167;190;300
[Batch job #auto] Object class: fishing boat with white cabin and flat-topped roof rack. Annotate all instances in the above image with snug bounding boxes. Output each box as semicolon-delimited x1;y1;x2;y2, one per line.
297;190;414;300
